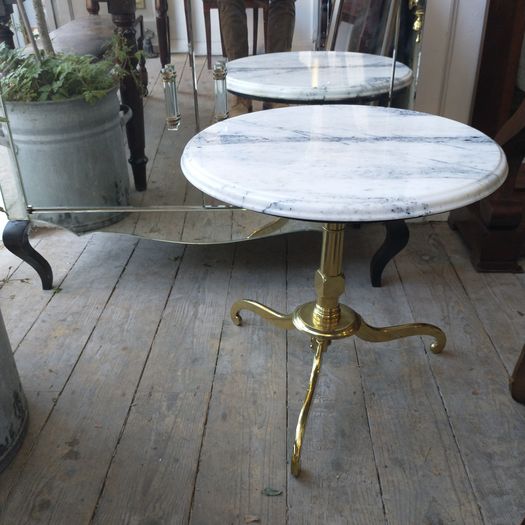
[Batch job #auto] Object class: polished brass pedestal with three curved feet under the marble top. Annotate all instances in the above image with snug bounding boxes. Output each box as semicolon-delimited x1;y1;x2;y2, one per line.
231;223;446;476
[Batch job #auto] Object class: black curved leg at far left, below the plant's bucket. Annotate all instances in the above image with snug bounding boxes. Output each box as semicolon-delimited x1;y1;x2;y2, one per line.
2;221;53;290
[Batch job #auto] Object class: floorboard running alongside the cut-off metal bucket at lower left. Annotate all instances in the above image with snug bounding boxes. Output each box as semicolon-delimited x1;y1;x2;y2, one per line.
0;234;137;512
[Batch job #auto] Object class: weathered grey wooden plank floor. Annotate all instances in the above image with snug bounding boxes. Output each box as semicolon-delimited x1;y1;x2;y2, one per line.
0;57;525;525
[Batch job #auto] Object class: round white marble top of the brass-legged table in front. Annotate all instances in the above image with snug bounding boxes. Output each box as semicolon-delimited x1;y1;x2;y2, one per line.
181;105;507;222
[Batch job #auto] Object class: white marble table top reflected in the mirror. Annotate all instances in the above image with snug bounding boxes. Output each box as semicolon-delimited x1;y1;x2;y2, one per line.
226;51;412;103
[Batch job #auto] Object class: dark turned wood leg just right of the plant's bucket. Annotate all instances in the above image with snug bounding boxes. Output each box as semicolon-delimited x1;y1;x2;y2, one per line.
108;7;148;191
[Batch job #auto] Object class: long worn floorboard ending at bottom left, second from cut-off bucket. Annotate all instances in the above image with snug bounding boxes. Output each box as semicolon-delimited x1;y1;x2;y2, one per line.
4;241;180;525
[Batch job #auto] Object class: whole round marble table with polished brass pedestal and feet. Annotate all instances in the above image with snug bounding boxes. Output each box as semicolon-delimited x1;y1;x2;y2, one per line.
181;105;507;476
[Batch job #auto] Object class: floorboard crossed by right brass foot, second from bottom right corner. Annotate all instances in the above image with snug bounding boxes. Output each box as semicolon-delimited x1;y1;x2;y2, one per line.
345;225;481;524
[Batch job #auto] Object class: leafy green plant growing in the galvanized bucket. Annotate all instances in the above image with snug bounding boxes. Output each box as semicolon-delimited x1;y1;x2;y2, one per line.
0;45;122;102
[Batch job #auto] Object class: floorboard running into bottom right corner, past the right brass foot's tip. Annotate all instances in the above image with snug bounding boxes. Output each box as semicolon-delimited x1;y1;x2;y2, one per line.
396;223;525;525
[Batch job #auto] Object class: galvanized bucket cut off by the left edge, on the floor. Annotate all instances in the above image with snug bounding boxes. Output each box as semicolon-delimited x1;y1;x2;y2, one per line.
0;312;28;472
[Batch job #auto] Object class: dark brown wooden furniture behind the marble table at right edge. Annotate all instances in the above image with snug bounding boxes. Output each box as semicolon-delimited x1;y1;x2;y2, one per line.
449;0;525;272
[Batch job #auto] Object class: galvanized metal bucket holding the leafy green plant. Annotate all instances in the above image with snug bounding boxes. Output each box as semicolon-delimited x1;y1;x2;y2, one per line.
2;88;131;233
